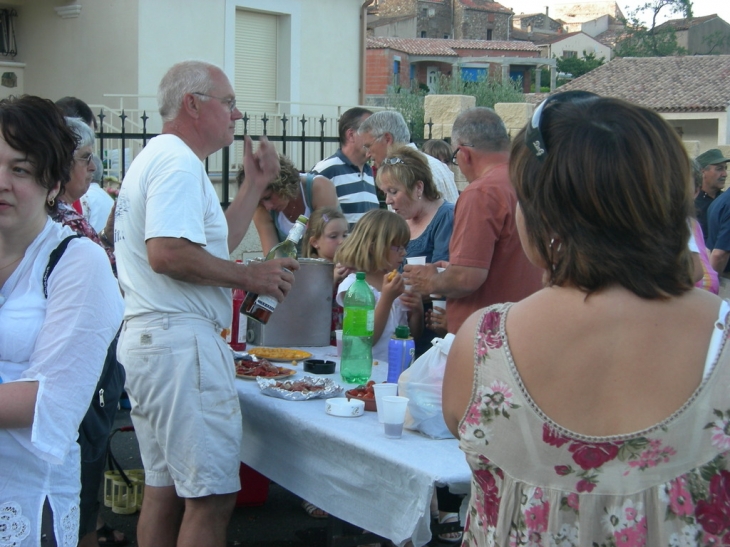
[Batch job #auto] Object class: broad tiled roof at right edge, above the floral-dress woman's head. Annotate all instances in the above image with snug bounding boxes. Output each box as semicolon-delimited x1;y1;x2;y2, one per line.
559;55;730;112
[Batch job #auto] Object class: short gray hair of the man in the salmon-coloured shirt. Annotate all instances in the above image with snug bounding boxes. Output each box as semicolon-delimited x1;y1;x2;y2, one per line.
451;106;510;152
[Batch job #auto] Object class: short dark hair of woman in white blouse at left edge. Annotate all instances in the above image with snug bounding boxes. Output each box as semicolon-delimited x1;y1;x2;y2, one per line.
0;95;77;207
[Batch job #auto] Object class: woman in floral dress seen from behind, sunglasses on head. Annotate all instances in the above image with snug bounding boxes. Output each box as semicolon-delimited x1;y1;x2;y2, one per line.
443;92;730;547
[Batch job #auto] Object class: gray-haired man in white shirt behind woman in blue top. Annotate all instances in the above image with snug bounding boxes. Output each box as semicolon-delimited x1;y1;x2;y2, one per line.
358;110;459;203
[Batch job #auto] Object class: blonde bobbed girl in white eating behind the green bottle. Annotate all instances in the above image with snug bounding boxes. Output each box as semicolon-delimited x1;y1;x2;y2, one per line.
335;209;423;361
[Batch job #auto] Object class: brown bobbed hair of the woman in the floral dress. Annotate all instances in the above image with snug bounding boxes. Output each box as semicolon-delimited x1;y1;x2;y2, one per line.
510;98;693;299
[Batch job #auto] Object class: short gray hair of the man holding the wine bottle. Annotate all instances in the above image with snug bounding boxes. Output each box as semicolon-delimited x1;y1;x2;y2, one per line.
157;61;220;122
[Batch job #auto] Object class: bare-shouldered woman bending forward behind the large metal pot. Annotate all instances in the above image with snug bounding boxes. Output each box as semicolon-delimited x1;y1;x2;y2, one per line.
243;154;340;255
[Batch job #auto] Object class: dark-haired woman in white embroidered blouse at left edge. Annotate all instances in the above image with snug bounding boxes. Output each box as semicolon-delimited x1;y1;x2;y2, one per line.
0;96;122;547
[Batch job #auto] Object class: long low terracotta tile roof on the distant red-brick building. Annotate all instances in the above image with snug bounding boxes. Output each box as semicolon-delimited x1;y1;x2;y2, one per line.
368;36;539;57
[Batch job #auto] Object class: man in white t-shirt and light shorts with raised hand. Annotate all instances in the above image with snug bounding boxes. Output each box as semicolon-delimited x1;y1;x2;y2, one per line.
114;61;298;547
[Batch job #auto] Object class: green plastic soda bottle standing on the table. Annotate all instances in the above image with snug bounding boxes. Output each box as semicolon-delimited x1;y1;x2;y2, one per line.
340;272;375;384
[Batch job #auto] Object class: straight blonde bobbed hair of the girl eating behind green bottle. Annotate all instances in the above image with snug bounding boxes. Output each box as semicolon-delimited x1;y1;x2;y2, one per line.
334;209;411;273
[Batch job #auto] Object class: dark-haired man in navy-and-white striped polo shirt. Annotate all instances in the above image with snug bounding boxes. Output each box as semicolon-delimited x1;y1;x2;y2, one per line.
312;107;380;229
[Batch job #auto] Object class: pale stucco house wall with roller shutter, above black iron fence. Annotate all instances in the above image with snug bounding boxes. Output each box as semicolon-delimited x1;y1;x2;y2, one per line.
13;0;363;123
